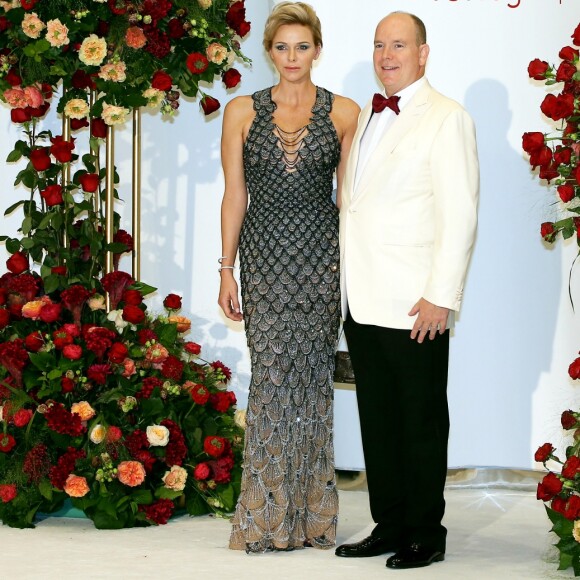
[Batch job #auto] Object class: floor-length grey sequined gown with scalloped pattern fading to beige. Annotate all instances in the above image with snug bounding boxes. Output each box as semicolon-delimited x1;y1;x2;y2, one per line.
230;87;340;552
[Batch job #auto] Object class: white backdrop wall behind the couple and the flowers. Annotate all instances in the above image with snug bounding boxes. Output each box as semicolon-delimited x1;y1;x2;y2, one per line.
0;0;580;467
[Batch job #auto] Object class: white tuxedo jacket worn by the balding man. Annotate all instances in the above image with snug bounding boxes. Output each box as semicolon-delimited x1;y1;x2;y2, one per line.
340;82;479;329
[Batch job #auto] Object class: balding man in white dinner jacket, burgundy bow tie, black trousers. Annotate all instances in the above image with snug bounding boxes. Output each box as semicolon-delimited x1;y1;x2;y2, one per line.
336;12;479;568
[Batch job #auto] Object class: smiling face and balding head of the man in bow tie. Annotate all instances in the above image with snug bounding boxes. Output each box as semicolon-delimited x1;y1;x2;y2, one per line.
373;14;429;97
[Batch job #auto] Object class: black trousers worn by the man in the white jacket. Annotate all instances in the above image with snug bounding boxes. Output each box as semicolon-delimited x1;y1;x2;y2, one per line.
344;314;449;551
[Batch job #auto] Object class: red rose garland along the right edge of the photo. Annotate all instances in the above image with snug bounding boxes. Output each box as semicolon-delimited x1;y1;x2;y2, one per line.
522;19;580;576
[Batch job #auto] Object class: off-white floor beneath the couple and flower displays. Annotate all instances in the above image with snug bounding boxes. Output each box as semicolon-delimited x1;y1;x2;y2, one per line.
0;488;573;580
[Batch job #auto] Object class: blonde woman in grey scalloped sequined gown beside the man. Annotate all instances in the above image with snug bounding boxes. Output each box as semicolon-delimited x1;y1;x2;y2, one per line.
219;2;359;552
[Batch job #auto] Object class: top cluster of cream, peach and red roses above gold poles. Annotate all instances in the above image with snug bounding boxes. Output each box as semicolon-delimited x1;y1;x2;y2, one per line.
0;0;250;118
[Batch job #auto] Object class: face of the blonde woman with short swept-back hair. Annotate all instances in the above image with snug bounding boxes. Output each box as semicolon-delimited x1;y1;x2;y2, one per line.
270;24;320;82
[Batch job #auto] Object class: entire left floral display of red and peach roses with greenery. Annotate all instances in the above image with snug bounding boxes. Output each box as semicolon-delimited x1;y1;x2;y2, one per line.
0;0;250;528
